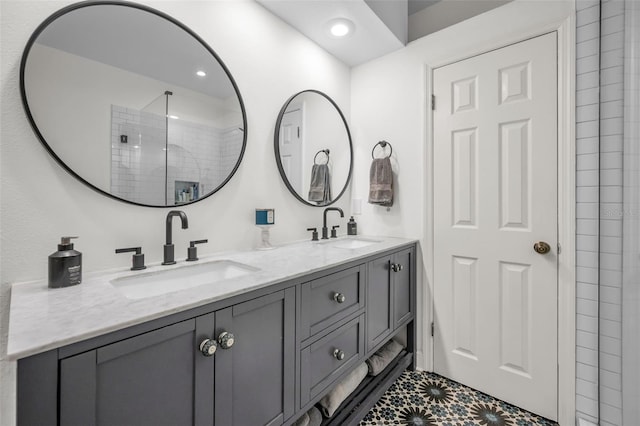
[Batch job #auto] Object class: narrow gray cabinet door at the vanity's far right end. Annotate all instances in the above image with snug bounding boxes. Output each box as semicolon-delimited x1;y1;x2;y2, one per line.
391;249;413;329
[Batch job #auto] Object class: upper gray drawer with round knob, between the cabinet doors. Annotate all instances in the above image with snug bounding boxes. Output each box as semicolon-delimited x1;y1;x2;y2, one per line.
299;265;365;340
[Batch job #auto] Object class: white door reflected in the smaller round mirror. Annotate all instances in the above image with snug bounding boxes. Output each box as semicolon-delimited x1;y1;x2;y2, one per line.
280;107;304;194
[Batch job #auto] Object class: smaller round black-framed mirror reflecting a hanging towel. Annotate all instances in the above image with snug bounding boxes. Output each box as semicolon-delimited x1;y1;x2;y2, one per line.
274;90;353;206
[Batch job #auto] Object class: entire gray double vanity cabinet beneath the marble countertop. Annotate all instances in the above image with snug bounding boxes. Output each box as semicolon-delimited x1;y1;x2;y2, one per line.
17;244;416;426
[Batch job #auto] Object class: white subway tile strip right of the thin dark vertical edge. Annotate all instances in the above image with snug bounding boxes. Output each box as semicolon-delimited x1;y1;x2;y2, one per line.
598;0;624;426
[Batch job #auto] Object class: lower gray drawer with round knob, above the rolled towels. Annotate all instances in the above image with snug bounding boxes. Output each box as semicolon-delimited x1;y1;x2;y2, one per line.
300;315;364;405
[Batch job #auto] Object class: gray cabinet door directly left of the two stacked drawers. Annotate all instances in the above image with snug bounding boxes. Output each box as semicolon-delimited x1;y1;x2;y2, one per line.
215;288;295;426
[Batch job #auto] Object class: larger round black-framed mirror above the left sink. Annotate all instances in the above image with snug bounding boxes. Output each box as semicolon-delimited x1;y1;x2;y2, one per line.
20;1;247;207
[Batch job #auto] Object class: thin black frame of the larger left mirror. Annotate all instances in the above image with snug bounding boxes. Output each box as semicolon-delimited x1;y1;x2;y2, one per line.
20;0;247;208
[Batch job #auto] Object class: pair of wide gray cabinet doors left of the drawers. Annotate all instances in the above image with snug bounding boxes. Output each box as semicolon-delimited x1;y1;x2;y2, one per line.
60;288;295;426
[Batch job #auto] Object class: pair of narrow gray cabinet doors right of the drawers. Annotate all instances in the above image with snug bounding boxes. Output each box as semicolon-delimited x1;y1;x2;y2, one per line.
366;249;415;351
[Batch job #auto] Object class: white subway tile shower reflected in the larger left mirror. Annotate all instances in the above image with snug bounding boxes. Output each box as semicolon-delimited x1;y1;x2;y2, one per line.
111;105;244;205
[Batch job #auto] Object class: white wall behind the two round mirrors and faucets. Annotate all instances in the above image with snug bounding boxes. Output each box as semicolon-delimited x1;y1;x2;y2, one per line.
0;0;350;426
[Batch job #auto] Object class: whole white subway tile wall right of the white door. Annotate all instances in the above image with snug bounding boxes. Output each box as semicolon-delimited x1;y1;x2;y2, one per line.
576;0;624;426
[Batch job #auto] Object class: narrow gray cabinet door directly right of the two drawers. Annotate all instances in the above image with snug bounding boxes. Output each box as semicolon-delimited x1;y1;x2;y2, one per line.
367;256;393;351
